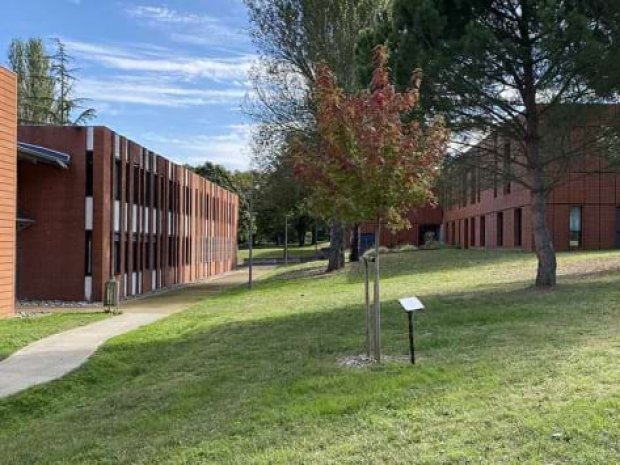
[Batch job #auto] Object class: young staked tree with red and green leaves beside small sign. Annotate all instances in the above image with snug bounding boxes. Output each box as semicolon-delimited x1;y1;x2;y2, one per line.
295;47;449;361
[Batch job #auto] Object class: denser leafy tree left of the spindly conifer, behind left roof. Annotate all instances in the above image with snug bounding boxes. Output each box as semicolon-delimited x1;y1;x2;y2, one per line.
9;37;54;124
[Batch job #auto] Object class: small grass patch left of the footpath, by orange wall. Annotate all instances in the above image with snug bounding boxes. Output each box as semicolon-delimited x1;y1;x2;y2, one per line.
0;313;106;360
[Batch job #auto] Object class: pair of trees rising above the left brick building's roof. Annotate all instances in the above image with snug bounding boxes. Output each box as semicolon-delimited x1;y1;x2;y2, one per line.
8;37;96;126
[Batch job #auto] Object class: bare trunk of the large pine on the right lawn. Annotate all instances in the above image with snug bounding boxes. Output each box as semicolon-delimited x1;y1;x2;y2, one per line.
532;191;557;288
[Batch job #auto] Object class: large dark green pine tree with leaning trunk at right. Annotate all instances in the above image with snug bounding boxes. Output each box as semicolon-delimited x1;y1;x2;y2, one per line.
366;0;620;287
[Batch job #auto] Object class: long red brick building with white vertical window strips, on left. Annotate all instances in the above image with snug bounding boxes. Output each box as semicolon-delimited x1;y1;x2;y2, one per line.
13;126;238;302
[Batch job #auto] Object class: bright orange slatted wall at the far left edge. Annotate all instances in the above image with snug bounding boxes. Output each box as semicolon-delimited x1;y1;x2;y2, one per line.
0;67;17;317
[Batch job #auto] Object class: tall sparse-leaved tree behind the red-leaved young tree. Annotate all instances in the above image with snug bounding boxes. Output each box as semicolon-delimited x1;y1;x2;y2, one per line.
245;0;384;271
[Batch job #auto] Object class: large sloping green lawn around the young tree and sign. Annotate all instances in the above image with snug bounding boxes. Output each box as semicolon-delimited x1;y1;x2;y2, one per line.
0;250;620;465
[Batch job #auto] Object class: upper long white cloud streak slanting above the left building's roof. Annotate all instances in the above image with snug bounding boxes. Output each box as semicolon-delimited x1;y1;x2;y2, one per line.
66;40;256;82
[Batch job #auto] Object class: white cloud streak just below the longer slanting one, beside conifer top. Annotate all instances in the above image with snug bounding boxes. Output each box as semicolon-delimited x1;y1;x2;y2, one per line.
78;76;246;107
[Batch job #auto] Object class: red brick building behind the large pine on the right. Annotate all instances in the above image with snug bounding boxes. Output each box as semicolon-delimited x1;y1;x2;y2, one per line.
442;111;620;251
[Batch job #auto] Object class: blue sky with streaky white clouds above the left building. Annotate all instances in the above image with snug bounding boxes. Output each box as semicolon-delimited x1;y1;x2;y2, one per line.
0;0;256;169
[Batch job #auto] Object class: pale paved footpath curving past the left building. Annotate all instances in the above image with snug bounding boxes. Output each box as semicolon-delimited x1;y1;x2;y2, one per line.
0;267;273;398
